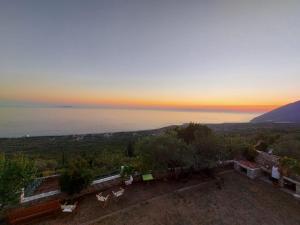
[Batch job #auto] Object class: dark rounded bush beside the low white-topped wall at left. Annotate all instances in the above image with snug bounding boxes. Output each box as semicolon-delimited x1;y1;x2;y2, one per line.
59;158;93;195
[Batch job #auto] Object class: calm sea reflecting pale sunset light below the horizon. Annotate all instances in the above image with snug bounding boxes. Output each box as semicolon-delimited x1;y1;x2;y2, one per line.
0;106;259;138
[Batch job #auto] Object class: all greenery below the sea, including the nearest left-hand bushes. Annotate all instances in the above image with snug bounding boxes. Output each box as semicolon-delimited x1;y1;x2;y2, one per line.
0;123;300;221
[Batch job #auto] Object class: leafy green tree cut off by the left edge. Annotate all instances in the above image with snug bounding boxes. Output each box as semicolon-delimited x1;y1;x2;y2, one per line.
0;154;37;210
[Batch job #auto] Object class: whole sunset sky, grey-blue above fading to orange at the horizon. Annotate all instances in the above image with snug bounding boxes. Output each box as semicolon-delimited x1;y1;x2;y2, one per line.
0;0;300;111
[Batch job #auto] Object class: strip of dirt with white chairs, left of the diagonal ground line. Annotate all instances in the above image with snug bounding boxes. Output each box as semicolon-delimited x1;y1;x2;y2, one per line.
25;170;216;224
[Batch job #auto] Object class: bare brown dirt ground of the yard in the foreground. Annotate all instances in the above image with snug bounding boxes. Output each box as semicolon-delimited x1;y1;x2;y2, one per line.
32;172;300;225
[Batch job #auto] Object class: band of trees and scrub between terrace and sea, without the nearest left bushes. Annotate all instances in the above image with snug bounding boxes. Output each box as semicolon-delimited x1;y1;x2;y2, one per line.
0;123;300;178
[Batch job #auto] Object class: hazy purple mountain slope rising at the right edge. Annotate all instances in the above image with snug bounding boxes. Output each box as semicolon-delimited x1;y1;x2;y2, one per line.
250;101;300;123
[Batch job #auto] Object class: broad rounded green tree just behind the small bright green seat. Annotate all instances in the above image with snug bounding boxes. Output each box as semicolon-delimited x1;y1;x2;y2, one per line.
136;134;193;171
